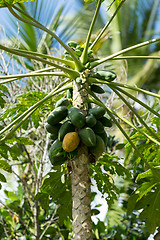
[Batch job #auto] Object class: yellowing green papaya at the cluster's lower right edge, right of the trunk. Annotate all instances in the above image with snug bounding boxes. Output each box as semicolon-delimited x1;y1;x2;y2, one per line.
89;135;105;157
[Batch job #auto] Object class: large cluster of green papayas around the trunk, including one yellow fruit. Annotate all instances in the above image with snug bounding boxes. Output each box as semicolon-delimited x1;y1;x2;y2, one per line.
46;98;112;165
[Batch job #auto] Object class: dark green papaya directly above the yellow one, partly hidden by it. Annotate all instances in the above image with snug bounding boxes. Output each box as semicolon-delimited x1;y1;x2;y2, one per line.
58;120;75;142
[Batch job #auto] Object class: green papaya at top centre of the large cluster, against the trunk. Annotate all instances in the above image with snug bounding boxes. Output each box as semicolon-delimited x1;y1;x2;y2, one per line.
68;107;85;128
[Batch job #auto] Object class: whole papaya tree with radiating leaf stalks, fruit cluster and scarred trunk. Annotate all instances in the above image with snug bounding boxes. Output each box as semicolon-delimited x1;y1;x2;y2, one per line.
0;0;160;240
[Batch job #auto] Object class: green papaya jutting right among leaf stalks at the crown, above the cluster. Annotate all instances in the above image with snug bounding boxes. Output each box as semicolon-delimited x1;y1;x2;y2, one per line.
92;70;117;82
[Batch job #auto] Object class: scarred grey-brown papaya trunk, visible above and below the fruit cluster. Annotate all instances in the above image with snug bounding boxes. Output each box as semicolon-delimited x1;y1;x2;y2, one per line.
71;79;92;240
